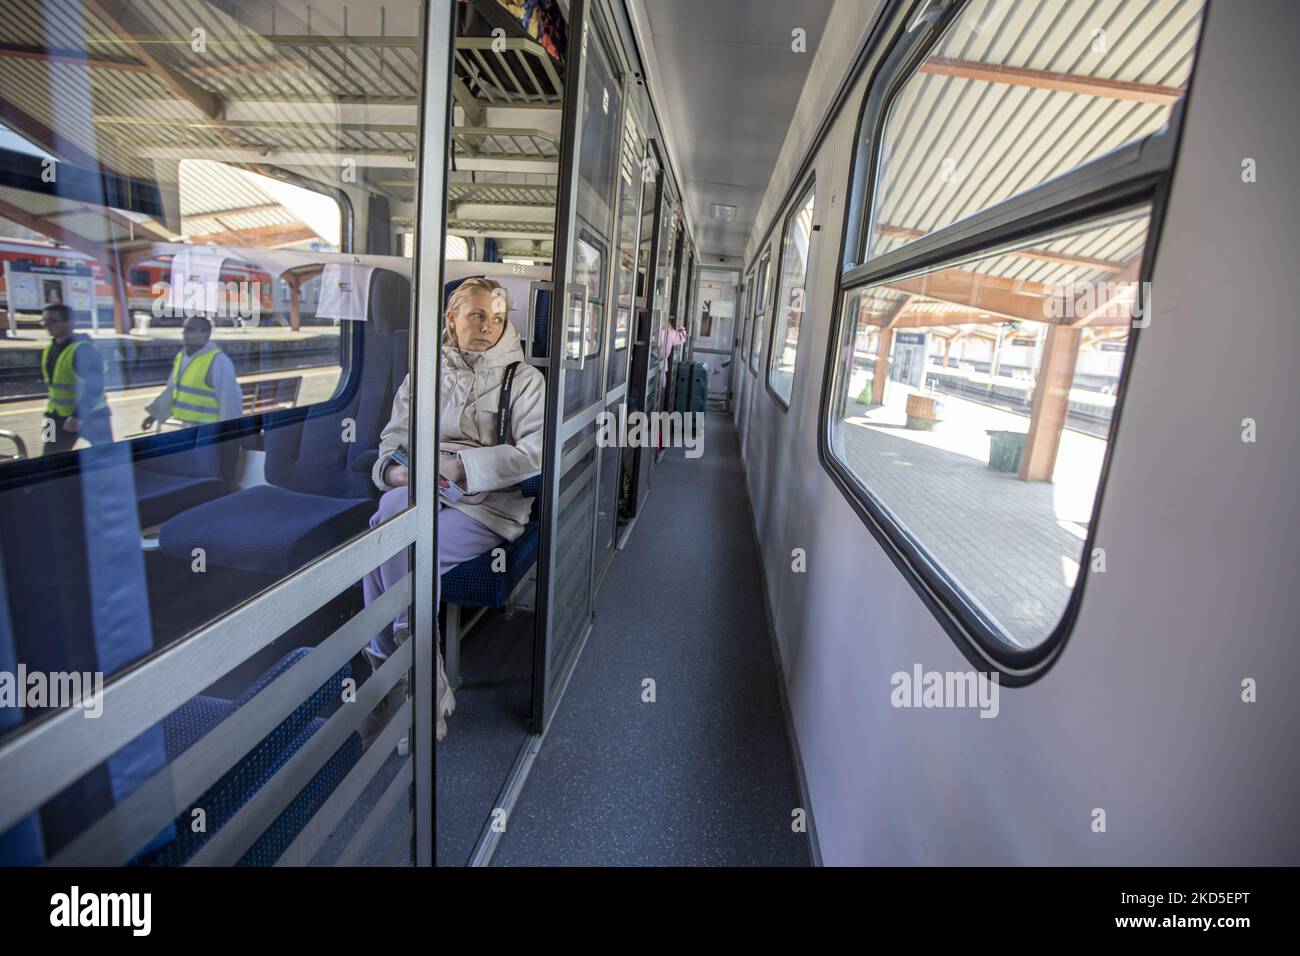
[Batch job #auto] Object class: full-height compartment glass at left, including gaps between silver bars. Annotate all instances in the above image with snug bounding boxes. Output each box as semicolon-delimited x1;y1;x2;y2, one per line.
0;0;425;864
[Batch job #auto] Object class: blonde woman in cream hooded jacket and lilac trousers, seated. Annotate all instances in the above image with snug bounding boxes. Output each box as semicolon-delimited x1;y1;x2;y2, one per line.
364;278;546;740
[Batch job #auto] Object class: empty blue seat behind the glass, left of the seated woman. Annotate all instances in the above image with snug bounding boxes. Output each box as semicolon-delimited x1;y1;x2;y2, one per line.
159;269;411;575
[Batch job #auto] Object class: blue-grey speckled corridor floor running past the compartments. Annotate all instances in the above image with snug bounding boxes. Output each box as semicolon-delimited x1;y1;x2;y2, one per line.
493;415;810;866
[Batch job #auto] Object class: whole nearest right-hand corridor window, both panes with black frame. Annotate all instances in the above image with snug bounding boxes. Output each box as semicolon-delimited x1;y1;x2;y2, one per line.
820;0;1200;680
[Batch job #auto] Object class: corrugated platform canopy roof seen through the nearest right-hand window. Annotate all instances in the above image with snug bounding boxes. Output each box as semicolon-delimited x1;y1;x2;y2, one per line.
847;0;1204;333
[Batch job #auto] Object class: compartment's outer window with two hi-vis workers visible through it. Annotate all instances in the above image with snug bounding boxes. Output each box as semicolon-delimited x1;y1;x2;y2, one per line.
0;155;342;460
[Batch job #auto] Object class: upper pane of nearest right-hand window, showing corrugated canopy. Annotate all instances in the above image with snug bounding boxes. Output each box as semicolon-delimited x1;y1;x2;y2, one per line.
866;0;1204;259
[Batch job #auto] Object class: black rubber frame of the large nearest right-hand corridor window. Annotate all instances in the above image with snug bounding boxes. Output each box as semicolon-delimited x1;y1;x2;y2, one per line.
818;0;1205;687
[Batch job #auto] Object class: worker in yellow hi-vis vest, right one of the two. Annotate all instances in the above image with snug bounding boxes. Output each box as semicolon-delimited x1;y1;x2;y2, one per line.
140;315;243;431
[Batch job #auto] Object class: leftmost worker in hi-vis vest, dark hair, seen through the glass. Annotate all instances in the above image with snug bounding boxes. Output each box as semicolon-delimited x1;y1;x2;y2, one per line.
40;302;113;455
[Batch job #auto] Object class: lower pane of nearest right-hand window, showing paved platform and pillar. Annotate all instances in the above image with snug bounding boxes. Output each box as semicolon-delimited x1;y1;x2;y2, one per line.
829;208;1149;648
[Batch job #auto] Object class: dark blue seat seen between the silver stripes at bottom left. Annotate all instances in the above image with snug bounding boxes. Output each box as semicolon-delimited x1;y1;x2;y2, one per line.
133;648;361;866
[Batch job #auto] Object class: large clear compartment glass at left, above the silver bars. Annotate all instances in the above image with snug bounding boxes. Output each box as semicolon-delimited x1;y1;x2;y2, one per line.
0;0;423;653
